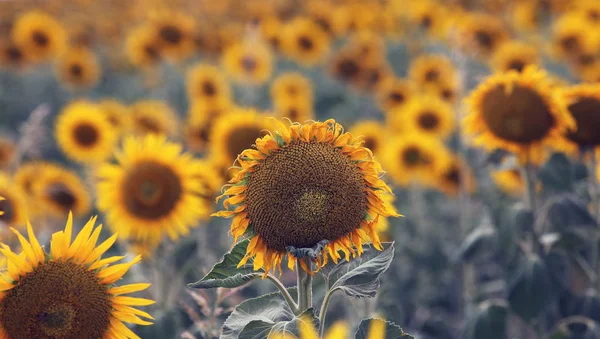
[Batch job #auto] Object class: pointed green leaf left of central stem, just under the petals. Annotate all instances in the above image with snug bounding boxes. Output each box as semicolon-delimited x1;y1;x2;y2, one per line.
188;240;264;289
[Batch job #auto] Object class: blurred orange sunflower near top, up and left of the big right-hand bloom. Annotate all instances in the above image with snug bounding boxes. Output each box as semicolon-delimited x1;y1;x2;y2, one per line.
456;13;509;58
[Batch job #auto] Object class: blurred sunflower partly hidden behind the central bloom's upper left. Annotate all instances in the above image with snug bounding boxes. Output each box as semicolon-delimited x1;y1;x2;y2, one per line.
209;109;269;166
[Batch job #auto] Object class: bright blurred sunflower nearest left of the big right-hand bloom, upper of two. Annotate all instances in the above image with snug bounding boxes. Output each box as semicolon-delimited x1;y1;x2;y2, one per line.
398;95;454;139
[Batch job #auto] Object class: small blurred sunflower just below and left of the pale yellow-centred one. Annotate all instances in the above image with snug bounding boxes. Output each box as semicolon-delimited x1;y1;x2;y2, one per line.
187;64;231;101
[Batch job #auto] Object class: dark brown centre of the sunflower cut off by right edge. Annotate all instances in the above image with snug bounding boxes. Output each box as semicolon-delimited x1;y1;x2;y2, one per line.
567;97;600;147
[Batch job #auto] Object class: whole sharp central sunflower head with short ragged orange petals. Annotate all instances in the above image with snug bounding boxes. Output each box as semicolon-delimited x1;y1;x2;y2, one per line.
215;120;397;274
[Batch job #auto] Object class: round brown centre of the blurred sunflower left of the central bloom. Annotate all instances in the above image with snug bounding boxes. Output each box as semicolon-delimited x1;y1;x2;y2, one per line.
122;162;183;220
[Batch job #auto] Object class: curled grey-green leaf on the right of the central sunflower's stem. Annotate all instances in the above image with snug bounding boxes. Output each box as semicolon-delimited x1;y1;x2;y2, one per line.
321;243;394;298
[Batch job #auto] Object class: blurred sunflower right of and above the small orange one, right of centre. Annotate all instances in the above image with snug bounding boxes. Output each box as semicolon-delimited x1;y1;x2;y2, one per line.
408;54;458;86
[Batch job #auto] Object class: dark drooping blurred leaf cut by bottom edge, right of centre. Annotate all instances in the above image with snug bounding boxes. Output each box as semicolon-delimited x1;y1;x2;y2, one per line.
464;300;508;339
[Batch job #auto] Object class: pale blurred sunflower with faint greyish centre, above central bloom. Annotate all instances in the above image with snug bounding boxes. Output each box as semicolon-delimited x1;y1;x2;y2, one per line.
223;42;273;85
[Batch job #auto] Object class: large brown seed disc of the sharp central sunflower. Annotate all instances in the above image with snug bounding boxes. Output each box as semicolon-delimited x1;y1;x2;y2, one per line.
246;142;367;251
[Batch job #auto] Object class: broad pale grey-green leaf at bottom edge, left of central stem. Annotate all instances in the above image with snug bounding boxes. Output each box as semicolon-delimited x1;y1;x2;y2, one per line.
221;288;317;339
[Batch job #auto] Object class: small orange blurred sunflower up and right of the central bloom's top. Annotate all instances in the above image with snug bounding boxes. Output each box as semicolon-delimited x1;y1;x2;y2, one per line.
375;77;417;113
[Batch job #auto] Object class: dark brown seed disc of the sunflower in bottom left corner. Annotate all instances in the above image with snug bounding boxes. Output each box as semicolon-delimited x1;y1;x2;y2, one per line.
0;261;112;339
